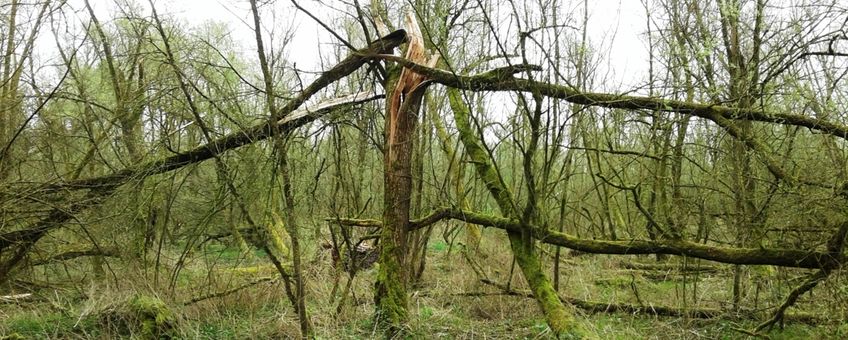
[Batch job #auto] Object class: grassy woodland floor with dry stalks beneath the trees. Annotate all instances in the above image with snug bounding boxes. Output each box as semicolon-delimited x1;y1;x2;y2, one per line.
0;226;848;339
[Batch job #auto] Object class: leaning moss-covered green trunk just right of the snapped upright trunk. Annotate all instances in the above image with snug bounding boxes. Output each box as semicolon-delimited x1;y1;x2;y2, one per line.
448;89;580;337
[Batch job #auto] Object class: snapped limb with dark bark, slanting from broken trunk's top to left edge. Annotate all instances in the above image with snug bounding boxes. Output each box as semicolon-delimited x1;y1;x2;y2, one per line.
0;30;406;283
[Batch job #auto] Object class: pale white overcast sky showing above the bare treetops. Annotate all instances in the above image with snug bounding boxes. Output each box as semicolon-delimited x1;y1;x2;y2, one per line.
59;0;648;91
